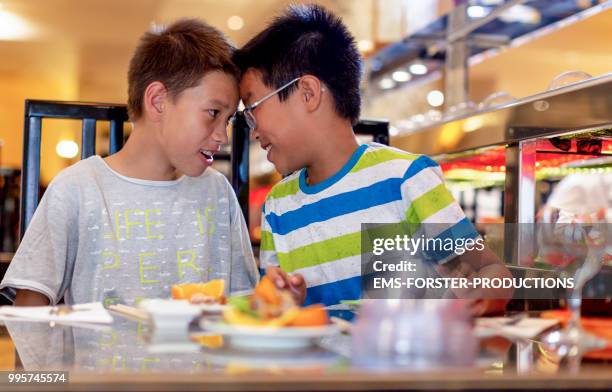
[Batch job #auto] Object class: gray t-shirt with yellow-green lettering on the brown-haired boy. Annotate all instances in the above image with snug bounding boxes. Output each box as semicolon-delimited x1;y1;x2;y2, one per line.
0;156;258;304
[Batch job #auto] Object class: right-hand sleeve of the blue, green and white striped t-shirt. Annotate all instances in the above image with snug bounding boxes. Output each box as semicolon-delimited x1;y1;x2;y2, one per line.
401;155;479;264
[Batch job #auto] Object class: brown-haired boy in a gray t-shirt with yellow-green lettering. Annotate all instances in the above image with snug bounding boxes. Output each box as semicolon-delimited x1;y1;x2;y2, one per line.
0;20;258;305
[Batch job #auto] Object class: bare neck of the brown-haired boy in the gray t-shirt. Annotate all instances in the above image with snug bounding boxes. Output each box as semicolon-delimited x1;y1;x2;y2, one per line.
105;121;182;181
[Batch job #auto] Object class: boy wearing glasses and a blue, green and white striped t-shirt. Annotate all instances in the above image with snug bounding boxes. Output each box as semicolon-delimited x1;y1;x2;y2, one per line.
234;5;510;314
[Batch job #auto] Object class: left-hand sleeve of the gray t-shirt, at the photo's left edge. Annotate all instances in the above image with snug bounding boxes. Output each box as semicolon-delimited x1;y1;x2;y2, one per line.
0;175;79;304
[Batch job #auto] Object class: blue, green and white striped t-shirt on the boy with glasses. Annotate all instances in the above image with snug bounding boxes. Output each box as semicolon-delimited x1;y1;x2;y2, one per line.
260;143;477;305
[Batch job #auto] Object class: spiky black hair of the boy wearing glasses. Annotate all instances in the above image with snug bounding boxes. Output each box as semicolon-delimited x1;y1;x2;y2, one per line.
234;5;361;124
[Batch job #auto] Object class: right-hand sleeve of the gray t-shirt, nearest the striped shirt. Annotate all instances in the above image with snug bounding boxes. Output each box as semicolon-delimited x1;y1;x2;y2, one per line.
227;179;259;294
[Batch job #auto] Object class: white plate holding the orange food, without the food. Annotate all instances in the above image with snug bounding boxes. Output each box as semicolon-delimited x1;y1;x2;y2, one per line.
201;319;340;350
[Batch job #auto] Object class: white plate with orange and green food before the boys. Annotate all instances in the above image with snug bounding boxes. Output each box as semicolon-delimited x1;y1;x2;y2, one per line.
201;276;340;350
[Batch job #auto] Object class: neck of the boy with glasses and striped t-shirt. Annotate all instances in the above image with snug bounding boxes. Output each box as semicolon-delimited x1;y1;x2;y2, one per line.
306;121;359;185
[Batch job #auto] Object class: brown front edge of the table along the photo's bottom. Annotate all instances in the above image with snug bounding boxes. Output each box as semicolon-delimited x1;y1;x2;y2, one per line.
0;366;612;391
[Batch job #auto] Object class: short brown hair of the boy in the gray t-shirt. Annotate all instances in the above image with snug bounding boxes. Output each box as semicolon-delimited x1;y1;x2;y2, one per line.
128;19;238;121
